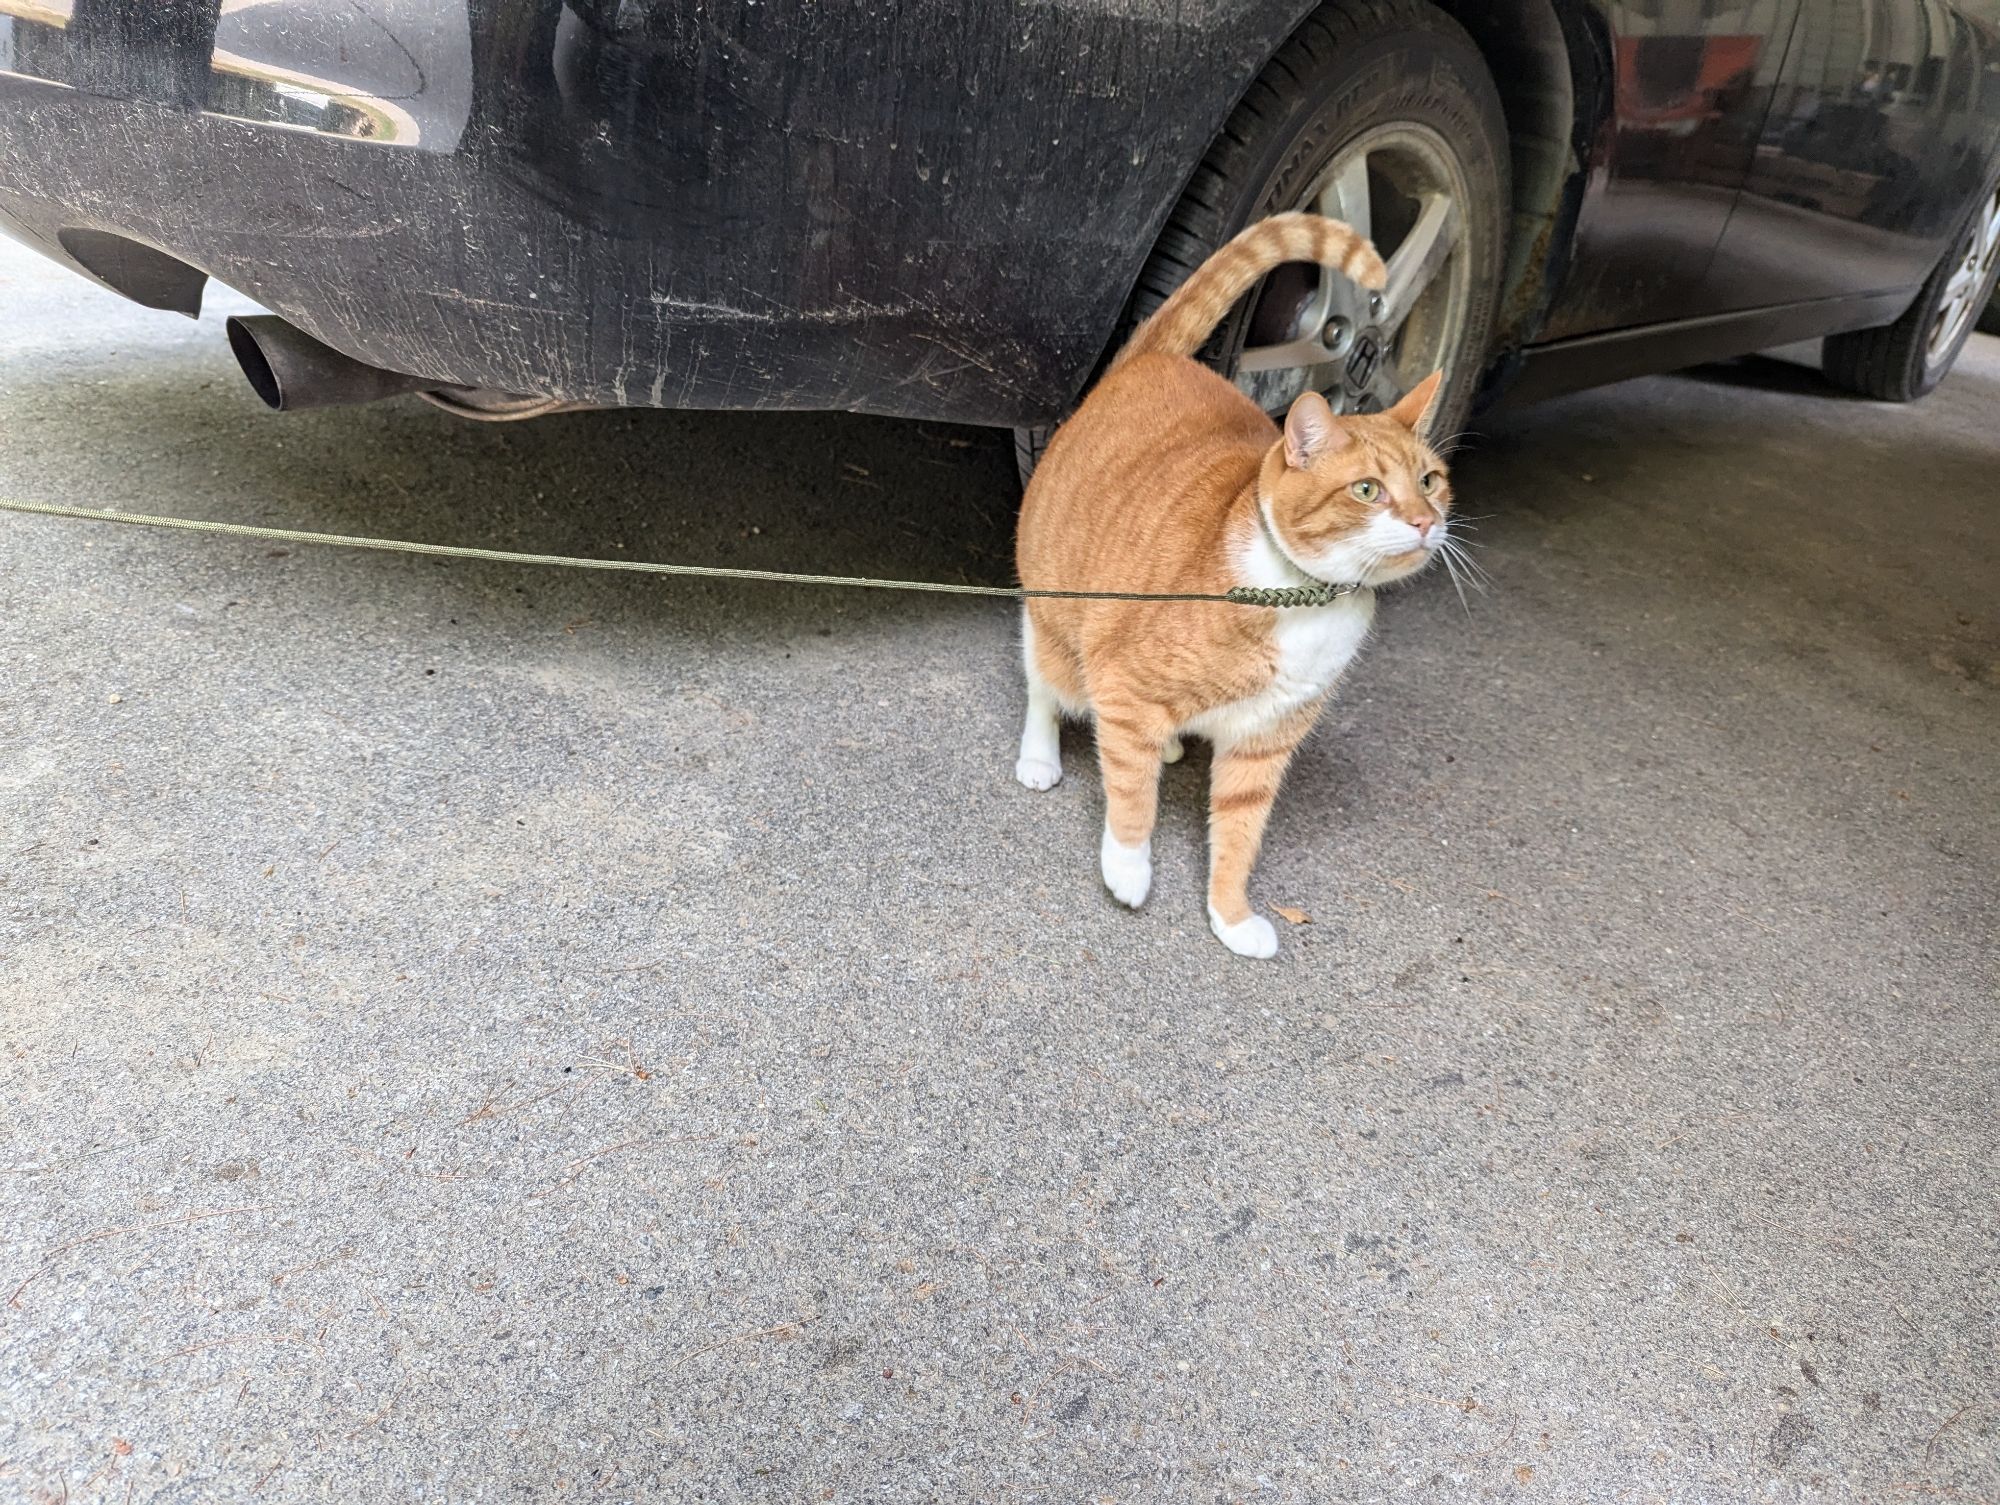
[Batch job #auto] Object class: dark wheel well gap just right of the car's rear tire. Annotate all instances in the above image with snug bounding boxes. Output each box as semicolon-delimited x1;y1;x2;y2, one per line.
1434;0;1596;354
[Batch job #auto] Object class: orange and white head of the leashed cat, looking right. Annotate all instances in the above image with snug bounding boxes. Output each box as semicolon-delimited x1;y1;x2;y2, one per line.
1258;372;1452;584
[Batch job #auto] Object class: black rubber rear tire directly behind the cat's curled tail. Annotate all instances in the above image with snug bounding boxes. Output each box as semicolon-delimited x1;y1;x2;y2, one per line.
1014;0;1508;484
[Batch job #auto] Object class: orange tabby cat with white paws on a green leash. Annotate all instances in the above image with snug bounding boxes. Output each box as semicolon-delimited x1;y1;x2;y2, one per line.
1014;214;1452;957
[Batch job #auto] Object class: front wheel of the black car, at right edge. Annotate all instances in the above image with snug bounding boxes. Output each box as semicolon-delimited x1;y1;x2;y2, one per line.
1820;182;2000;402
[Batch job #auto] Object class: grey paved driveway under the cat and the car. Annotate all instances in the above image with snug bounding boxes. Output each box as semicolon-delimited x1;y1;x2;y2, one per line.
0;250;2000;1503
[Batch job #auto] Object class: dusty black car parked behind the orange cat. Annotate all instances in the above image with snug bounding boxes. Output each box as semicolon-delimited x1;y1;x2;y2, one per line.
0;0;2000;476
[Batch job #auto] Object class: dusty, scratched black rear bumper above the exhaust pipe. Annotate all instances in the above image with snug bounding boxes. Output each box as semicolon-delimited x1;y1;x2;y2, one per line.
0;0;1278;424
